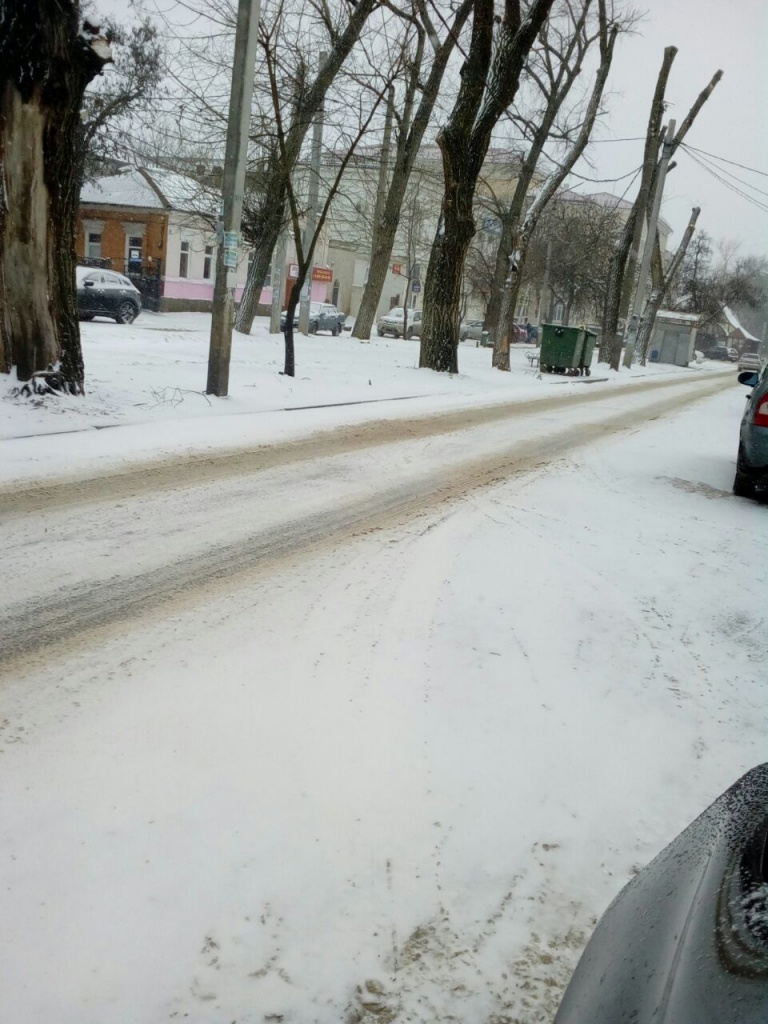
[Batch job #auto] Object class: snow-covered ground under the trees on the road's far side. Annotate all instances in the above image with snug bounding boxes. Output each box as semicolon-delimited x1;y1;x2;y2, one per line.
0;312;727;477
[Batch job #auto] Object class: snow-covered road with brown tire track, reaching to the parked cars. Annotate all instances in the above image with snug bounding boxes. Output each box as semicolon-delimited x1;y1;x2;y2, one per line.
0;378;768;1024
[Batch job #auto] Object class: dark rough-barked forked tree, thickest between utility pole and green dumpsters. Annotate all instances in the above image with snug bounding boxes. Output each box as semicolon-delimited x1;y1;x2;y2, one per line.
419;0;554;373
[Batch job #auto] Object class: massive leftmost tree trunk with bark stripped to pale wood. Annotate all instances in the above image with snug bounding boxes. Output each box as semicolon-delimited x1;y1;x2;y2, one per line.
0;0;112;393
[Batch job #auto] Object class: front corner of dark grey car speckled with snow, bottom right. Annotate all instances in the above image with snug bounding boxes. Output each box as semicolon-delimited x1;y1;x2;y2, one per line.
555;764;768;1024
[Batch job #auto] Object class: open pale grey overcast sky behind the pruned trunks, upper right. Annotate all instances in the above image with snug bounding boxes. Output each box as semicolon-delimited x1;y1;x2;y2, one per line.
102;0;768;256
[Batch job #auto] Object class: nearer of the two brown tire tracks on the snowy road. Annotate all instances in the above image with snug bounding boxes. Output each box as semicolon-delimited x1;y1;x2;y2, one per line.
0;377;731;675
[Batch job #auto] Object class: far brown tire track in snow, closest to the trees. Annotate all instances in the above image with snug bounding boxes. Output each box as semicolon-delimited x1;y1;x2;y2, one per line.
0;374;732;521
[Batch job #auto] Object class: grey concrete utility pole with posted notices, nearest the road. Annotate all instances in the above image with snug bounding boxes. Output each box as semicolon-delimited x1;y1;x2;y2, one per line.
206;0;261;398
